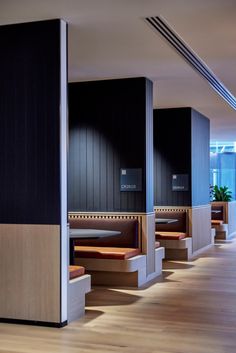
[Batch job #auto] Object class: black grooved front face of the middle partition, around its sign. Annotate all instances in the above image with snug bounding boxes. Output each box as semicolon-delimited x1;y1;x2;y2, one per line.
68;78;152;212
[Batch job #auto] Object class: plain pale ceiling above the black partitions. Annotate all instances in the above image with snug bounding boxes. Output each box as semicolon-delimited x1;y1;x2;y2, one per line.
0;0;236;141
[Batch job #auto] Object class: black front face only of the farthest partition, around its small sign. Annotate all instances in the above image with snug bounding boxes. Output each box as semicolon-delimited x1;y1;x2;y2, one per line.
154;108;191;206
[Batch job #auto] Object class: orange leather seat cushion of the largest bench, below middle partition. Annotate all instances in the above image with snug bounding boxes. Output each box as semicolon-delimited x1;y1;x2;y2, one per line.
75;246;140;260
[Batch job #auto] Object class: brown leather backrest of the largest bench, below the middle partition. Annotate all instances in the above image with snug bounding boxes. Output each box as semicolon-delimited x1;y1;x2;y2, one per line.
69;218;140;248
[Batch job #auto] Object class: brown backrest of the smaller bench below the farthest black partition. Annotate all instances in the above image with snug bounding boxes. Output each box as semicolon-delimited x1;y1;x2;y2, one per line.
155;210;187;233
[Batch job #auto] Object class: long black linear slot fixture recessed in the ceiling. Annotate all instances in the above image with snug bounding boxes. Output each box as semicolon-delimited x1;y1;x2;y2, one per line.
145;16;236;110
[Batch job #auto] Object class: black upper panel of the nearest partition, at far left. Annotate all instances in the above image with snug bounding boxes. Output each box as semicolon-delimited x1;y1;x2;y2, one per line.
0;20;60;224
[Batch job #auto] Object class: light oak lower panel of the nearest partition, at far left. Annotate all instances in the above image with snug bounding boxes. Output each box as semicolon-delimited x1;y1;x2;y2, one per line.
0;224;60;323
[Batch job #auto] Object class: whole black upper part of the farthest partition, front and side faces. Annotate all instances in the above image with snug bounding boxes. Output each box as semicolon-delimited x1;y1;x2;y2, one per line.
154;108;209;206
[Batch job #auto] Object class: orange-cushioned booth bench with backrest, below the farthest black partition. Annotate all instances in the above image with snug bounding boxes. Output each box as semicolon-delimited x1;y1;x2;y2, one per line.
155;210;192;260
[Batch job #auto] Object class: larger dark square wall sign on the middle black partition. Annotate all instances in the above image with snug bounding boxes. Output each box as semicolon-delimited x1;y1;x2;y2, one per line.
120;168;142;191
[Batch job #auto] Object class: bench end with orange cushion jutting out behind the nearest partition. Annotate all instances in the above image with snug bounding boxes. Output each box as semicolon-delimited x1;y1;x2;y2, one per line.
67;266;91;323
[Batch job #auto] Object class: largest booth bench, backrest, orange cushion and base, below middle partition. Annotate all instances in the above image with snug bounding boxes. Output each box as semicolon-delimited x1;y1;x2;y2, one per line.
69;216;164;287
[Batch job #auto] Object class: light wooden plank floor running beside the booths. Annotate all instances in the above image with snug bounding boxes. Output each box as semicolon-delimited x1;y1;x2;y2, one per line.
0;240;236;353
